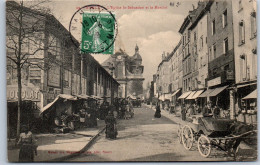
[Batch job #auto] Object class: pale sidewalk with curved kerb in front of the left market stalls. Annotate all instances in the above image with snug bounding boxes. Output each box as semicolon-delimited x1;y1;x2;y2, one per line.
8;120;105;162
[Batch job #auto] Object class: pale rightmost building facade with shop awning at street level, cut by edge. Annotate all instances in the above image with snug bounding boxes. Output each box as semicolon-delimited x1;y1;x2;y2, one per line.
230;0;257;123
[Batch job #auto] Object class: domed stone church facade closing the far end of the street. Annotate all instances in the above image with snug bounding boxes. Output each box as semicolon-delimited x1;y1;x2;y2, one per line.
102;45;144;98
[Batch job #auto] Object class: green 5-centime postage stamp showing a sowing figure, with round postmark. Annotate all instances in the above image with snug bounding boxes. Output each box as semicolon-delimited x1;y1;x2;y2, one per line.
81;13;115;54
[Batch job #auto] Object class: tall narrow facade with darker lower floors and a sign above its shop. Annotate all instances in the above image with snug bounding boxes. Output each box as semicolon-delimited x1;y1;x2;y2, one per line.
207;0;235;86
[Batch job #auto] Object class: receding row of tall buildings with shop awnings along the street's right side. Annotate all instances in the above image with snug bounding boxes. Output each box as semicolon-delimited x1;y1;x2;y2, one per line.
150;0;257;121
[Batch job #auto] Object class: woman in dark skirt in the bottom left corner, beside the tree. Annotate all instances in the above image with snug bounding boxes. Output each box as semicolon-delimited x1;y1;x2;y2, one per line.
17;126;37;162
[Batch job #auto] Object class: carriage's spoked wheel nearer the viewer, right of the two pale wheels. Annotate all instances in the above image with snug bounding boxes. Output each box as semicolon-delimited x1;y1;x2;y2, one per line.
198;135;211;158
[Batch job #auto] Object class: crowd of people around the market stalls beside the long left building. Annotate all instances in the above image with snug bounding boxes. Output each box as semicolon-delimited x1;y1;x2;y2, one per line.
51;98;134;133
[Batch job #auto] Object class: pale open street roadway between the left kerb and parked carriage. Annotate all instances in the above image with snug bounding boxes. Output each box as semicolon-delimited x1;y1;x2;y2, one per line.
70;106;252;162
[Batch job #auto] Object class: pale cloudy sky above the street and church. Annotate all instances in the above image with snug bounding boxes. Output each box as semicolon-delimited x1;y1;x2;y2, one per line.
33;0;197;89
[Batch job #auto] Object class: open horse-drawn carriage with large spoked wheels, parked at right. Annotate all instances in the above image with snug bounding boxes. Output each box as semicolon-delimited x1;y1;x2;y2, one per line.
178;116;257;158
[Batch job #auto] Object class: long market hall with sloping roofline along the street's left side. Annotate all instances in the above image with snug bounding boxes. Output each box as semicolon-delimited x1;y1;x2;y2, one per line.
6;1;120;117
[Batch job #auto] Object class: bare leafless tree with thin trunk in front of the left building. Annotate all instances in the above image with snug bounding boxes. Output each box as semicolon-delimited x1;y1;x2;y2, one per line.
6;0;68;137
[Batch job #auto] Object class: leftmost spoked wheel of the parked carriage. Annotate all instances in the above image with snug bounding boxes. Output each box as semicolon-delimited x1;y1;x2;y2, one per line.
182;125;194;150
